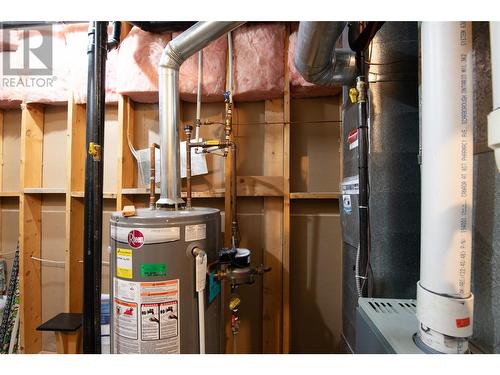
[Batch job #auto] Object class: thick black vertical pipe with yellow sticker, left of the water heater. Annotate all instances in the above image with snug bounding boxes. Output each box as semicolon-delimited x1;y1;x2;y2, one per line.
83;22;108;354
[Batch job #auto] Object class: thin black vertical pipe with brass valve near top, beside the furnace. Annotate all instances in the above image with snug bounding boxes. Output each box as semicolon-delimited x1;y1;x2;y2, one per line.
356;52;370;296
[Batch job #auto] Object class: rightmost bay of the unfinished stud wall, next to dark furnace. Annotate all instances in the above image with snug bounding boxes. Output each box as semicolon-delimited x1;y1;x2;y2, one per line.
290;97;342;353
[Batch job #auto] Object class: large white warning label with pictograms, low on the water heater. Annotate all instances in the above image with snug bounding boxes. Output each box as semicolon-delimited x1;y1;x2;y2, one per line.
114;279;180;354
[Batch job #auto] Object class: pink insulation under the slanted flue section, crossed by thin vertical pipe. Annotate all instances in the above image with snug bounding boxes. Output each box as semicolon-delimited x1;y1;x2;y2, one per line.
172;33;227;102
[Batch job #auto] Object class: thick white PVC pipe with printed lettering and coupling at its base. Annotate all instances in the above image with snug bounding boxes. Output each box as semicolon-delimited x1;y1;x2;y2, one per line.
417;22;473;353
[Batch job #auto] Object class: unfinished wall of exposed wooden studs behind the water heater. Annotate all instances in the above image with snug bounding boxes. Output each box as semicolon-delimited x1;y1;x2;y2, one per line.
0;25;342;353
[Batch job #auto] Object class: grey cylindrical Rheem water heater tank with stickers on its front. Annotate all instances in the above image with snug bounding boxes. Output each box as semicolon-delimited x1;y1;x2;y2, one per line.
110;208;224;354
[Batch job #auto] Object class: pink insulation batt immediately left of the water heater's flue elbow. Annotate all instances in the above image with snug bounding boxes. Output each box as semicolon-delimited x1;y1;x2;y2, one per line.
117;27;171;103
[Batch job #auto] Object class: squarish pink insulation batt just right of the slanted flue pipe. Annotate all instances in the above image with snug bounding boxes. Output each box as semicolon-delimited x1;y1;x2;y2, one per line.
233;23;285;101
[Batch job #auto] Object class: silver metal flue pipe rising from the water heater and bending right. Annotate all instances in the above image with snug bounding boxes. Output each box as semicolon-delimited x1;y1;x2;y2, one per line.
157;22;244;209
